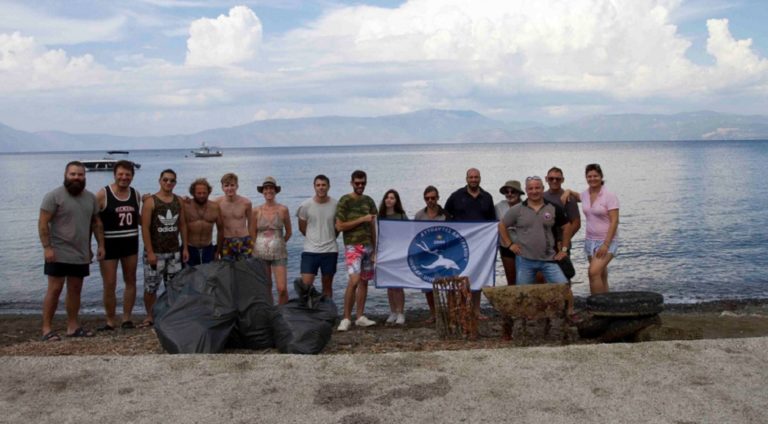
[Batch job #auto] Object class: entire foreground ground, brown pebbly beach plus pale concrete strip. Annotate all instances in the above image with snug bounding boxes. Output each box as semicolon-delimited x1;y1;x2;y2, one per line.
0;301;768;424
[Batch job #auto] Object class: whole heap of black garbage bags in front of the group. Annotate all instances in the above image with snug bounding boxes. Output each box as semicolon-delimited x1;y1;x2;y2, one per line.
153;259;336;353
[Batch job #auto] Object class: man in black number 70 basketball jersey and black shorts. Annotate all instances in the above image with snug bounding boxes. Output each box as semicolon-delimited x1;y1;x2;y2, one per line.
96;160;141;331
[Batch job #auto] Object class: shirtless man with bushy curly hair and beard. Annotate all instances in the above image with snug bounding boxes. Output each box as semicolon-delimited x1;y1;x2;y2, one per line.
184;178;224;266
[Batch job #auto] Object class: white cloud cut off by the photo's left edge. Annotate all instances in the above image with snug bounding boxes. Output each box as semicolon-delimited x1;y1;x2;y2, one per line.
0;32;107;92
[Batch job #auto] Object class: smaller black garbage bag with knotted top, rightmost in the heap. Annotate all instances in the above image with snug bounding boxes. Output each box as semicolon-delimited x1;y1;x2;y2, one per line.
276;278;337;354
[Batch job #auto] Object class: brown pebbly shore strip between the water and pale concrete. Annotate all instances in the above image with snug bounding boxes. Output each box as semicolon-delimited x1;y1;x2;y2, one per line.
0;299;768;356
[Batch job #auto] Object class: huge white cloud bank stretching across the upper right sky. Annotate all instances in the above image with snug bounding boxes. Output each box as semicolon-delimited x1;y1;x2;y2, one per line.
265;0;765;100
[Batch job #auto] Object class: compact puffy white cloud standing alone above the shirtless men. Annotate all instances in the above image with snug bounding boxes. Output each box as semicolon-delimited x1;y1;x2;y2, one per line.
186;6;262;67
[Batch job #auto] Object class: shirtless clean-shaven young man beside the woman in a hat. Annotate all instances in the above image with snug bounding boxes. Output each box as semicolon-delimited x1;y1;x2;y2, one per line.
214;172;253;261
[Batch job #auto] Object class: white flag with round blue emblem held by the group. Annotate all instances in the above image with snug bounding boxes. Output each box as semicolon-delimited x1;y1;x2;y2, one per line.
375;220;499;290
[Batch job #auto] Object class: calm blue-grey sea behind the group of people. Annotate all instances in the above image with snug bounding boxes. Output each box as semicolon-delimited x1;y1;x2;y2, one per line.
0;141;768;313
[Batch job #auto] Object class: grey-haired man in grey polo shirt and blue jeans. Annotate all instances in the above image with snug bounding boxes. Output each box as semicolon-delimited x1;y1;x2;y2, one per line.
499;177;572;284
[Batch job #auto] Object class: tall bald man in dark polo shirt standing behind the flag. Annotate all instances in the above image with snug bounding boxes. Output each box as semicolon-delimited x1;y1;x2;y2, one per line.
445;168;496;319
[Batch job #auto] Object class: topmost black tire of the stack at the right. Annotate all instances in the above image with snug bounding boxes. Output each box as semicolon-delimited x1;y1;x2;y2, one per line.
587;291;664;317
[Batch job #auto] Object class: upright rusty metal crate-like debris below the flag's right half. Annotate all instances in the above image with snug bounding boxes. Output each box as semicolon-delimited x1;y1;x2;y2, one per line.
432;277;477;340
